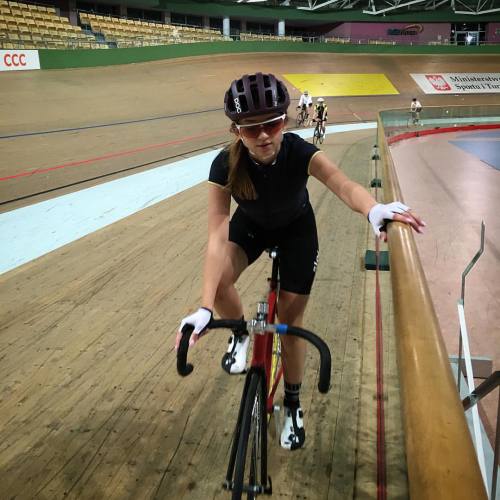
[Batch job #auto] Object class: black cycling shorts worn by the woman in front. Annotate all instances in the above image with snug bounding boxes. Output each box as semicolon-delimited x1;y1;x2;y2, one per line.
229;203;319;295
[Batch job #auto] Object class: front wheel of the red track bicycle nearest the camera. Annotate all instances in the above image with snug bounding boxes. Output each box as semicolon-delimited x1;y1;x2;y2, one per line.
231;370;267;500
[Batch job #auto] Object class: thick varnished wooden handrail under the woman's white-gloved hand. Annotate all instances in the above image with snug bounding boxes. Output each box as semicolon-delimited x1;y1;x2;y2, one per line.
378;115;487;500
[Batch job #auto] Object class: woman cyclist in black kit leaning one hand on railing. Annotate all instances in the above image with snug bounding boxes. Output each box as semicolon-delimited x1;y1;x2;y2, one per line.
177;73;424;450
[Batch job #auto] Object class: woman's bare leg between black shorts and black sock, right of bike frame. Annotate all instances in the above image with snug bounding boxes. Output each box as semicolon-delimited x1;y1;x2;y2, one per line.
278;290;309;384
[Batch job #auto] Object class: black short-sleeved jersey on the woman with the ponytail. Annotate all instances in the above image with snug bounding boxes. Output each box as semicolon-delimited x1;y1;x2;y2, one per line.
208;132;319;229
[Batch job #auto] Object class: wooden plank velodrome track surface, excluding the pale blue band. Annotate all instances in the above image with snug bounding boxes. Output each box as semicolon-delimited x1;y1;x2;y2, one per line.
0;54;499;499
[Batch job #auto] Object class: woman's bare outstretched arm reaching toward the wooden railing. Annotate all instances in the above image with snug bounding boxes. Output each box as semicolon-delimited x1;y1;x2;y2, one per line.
309;152;377;216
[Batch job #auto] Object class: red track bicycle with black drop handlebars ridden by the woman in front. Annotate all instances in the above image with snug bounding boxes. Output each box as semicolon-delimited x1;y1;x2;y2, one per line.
177;248;331;500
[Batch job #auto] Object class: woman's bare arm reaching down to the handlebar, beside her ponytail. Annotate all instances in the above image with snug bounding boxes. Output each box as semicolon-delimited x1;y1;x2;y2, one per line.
201;184;231;310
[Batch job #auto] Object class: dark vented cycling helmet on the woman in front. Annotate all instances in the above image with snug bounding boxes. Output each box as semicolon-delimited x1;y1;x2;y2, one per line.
224;73;290;122
